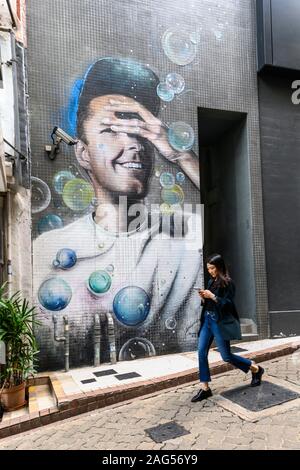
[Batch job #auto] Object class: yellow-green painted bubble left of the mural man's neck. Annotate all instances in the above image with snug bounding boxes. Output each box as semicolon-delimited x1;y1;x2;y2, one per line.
62;178;95;211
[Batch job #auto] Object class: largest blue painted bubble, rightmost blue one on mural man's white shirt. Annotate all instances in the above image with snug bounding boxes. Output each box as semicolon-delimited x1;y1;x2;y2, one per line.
113;286;150;326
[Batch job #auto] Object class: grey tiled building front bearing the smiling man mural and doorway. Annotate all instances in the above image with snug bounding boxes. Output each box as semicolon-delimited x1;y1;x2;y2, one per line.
20;0;300;369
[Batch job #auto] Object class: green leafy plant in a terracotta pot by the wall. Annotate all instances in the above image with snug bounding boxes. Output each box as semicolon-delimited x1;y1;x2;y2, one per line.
0;284;38;411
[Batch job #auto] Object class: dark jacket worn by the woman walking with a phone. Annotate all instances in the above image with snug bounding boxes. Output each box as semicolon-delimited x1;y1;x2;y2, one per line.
199;279;242;340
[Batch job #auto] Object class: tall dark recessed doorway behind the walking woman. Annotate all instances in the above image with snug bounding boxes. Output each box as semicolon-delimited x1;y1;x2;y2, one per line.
198;108;257;336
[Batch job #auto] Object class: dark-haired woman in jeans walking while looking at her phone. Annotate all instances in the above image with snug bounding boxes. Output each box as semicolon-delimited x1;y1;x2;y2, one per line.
191;254;264;402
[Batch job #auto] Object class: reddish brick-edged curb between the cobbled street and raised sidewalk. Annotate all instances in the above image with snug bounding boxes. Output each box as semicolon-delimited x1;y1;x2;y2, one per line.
0;343;300;439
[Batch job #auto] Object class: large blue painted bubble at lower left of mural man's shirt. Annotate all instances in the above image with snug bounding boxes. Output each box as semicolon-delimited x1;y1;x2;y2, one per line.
38;277;72;312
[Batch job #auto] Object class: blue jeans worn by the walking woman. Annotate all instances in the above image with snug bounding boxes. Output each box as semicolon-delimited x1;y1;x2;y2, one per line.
198;312;251;382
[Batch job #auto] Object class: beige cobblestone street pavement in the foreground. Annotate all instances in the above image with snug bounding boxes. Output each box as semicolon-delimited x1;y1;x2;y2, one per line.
0;351;300;450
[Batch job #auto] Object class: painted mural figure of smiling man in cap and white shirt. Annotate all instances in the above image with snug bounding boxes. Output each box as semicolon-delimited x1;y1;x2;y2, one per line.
34;57;202;369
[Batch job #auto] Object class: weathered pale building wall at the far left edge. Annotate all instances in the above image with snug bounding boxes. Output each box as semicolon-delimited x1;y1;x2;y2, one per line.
0;0;32;301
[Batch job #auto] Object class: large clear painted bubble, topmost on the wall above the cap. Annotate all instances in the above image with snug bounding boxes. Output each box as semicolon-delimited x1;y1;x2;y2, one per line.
162;28;197;65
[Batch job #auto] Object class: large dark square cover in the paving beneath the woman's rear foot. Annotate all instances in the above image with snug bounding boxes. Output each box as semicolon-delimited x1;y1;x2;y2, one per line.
221;382;300;411
